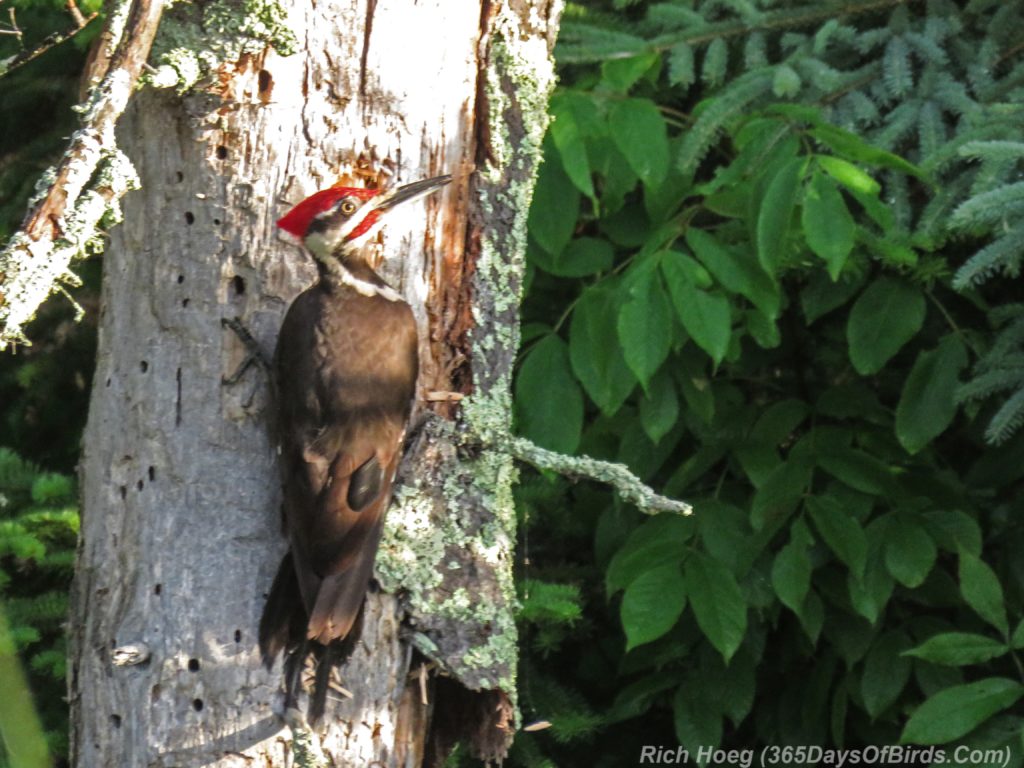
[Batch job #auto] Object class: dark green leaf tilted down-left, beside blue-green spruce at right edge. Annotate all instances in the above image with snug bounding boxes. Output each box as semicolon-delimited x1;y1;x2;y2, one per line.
896;334;967;454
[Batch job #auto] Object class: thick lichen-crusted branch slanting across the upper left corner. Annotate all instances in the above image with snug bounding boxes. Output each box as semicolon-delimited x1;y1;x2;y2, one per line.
0;0;164;349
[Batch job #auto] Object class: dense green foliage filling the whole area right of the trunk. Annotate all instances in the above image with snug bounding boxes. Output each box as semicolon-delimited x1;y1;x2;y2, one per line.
516;0;1024;766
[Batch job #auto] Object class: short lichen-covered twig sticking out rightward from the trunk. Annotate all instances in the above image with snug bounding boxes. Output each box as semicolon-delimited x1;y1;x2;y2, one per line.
507;437;693;515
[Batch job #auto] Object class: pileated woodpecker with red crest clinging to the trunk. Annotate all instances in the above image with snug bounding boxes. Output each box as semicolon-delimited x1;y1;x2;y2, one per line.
259;176;452;721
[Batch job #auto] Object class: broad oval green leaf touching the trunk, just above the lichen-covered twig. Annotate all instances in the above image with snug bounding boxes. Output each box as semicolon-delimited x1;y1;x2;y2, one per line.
515;334;583;454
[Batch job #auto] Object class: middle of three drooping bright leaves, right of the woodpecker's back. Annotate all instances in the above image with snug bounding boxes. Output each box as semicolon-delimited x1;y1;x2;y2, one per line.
617;269;672;390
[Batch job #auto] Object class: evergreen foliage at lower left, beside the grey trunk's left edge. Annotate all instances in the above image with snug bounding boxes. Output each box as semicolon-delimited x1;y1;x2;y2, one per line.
0;447;79;765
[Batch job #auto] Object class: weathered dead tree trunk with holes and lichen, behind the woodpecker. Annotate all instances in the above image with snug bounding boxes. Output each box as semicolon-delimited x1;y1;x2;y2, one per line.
70;0;559;768
